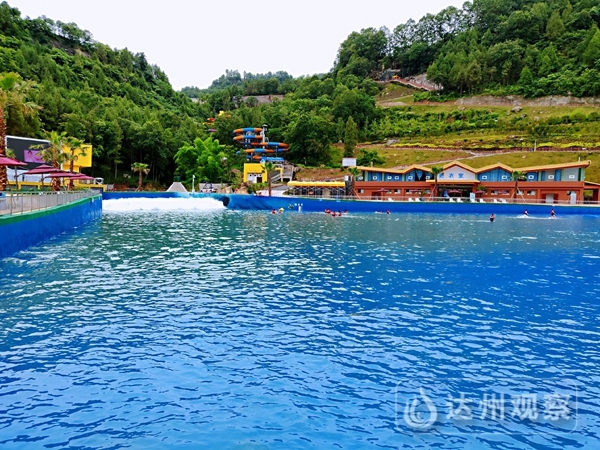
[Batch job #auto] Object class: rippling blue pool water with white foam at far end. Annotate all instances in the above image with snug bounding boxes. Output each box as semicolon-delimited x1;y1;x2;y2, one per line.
0;199;600;449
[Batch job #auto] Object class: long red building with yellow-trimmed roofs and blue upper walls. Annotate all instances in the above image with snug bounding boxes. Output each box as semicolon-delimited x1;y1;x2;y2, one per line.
354;161;600;204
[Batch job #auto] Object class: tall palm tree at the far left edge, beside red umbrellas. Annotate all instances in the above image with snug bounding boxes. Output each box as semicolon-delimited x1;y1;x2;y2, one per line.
0;72;40;191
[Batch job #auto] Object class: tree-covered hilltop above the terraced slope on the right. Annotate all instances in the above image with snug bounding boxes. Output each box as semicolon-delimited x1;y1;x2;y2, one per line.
335;0;600;97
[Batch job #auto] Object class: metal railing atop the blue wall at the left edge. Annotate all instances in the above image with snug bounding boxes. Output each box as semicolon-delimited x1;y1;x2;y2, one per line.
0;191;98;216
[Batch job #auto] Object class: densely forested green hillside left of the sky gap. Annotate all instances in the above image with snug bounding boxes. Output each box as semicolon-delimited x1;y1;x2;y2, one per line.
0;2;209;180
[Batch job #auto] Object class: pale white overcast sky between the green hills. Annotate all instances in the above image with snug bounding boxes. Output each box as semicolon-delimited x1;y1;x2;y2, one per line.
8;0;464;90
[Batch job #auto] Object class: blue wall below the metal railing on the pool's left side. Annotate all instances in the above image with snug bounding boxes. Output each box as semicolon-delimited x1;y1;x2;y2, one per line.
0;195;102;258
